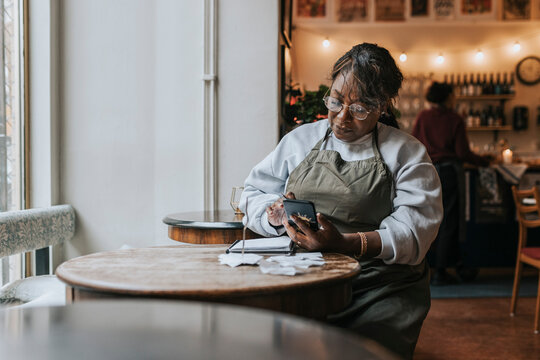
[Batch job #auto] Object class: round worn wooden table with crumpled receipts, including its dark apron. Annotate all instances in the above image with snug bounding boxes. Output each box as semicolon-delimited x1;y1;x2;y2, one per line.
56;245;360;318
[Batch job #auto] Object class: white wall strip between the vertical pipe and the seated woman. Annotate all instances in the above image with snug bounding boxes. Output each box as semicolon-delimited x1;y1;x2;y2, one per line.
218;0;278;209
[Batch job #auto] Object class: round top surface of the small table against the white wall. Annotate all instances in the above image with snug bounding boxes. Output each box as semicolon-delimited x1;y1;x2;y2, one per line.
163;210;244;229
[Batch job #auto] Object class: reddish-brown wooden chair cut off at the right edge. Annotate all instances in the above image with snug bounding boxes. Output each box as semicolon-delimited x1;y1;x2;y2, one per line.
510;186;540;334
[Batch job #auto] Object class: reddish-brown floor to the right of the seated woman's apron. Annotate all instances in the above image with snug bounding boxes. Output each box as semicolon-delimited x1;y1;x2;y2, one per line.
414;297;540;360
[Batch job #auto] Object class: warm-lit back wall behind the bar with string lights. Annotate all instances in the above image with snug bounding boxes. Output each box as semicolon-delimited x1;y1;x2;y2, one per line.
292;21;540;151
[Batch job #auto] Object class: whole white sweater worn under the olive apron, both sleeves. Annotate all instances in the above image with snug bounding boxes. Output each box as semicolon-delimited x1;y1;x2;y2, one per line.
240;120;443;265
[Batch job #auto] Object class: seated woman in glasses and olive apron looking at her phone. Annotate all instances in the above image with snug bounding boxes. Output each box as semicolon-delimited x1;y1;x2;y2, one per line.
241;43;442;358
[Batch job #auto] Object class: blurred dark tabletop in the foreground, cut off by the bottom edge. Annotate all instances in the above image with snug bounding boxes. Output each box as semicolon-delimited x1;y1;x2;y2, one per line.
0;300;395;360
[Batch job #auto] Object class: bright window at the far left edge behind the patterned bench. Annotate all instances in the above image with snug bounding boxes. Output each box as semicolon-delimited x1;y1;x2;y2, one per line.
0;0;24;284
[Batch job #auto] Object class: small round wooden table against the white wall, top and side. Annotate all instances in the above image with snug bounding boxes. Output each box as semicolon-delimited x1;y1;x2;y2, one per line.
163;210;261;244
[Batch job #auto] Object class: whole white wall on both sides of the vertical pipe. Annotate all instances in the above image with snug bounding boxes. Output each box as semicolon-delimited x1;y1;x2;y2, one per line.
52;0;277;258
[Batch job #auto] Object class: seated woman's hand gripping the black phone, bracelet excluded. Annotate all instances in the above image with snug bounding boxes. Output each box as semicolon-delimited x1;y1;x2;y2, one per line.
283;213;344;251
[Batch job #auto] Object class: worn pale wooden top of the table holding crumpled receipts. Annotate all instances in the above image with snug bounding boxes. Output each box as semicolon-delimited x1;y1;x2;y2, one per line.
56;245;360;297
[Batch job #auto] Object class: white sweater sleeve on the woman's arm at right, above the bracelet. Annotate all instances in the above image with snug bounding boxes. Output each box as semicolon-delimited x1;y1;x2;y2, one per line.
377;134;443;265
